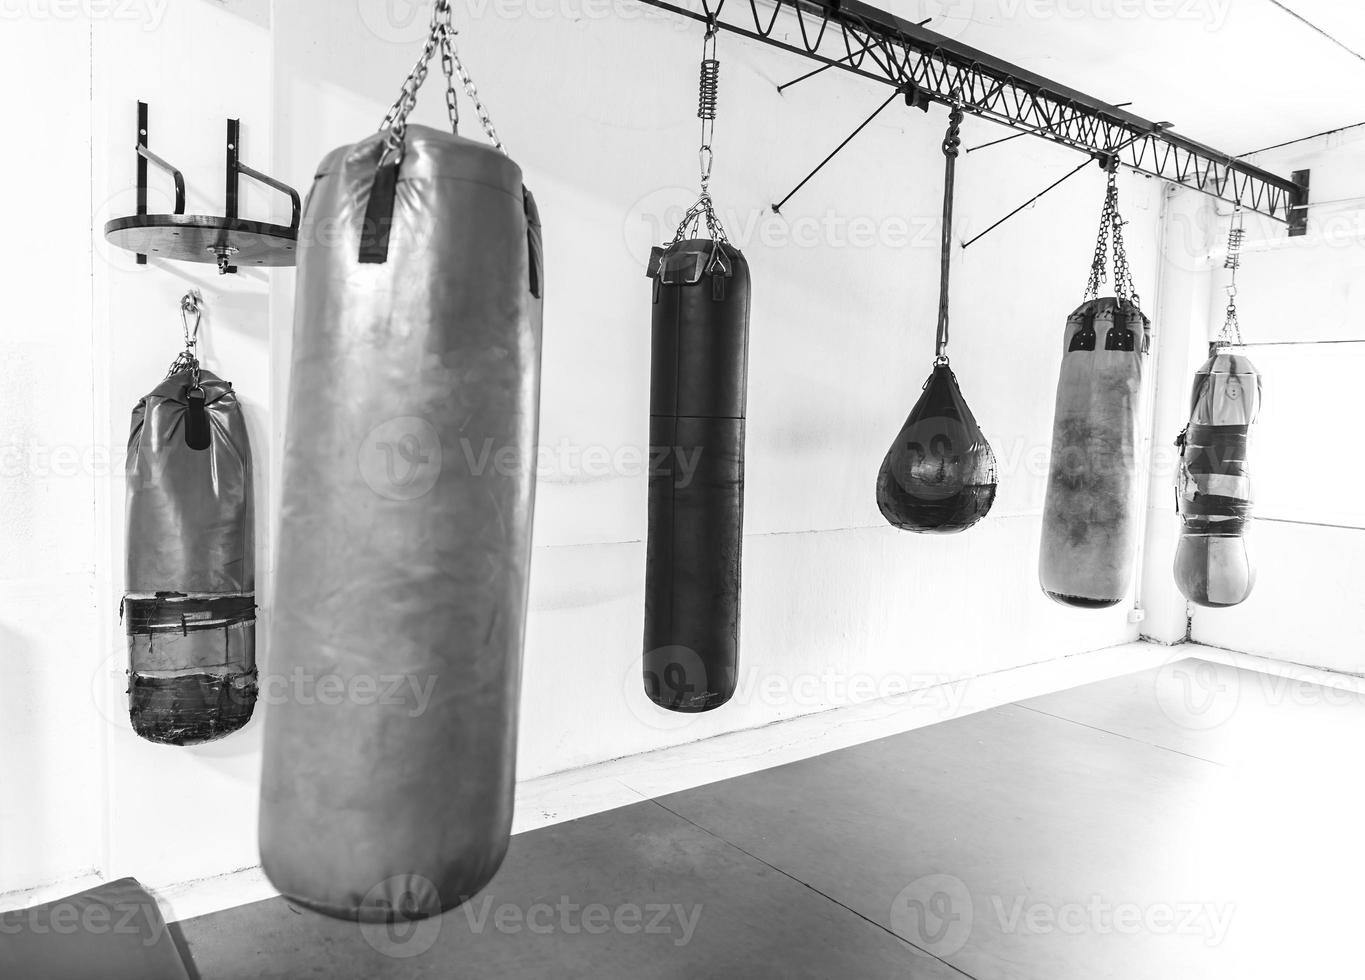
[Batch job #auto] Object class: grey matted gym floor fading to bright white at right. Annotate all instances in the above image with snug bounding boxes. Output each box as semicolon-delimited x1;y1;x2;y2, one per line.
175;661;1365;980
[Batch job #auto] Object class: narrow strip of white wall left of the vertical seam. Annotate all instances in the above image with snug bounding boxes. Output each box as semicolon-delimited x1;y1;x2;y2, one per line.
0;22;98;891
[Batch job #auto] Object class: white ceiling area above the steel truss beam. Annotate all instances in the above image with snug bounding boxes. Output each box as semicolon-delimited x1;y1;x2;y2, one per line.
876;0;1365;154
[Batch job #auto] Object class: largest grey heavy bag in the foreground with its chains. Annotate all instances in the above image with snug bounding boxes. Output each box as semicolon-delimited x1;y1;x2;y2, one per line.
261;0;543;923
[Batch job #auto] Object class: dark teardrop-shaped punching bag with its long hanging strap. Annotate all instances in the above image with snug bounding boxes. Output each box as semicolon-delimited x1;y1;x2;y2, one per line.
876;108;996;534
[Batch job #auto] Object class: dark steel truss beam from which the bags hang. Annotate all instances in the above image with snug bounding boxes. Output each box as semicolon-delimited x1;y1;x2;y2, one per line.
640;0;1308;235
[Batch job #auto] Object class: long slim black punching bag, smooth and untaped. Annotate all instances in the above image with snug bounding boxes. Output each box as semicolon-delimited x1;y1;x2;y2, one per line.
643;239;749;712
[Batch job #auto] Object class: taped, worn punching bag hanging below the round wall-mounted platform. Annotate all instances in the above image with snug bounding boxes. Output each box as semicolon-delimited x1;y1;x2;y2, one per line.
120;369;257;745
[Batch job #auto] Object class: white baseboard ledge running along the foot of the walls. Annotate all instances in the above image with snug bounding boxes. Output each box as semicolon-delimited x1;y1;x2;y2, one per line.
13;643;1310;921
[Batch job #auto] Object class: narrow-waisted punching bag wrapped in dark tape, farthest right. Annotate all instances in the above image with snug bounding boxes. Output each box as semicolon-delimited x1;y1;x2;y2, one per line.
1175;351;1261;607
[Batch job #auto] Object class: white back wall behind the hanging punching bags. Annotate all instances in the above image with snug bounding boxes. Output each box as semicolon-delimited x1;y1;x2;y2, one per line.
0;0;1160;906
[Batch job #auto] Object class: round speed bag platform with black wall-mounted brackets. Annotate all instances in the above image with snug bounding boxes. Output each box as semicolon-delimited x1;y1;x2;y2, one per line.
104;102;302;273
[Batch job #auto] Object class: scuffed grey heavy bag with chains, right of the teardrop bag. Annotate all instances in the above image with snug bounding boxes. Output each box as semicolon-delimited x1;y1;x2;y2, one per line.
1039;169;1151;609
